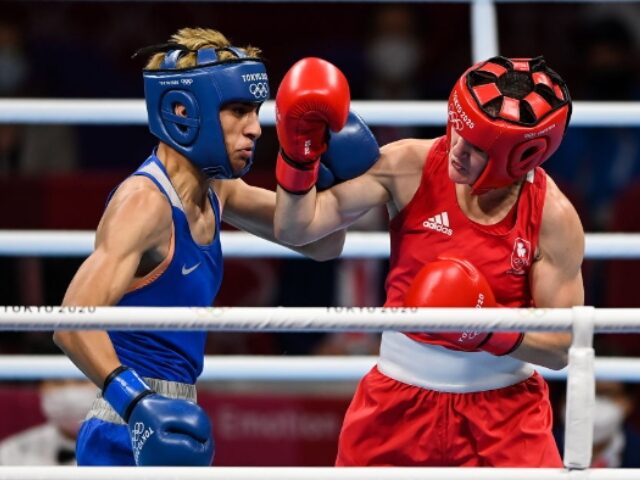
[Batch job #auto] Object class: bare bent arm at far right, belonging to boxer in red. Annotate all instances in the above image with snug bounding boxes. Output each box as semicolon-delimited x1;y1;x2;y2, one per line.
512;179;584;369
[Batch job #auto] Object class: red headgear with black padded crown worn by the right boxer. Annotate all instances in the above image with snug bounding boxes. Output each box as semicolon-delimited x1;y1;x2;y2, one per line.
447;57;571;195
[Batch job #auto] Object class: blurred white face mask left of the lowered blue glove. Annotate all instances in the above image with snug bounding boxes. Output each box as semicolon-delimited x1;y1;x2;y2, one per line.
40;385;96;435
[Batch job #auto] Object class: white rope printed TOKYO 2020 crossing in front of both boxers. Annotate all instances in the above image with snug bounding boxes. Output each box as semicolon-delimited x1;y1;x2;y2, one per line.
0;306;640;333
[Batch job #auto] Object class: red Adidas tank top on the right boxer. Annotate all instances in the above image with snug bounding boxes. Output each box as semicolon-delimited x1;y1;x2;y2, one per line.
385;137;547;345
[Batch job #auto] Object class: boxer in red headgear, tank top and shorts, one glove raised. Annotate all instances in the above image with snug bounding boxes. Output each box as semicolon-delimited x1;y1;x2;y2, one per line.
274;57;584;467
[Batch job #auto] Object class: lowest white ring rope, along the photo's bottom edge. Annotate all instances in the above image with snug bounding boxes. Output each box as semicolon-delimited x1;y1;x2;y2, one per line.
0;467;640;480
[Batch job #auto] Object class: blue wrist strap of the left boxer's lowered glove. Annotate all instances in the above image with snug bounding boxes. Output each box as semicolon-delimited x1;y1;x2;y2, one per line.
102;366;153;422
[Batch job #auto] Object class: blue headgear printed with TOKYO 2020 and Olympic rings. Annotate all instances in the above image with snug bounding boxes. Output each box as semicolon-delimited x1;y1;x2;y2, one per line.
143;44;269;178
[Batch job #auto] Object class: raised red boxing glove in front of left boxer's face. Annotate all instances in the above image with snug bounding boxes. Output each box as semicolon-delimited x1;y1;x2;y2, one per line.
276;57;351;194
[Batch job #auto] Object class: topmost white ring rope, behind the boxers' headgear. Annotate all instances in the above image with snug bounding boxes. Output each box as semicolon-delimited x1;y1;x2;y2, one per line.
0;98;640;127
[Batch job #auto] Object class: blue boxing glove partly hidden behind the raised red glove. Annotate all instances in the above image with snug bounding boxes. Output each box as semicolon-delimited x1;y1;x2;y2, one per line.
316;112;380;190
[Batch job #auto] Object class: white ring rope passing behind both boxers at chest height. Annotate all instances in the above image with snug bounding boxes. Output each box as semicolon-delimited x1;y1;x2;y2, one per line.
0;230;640;260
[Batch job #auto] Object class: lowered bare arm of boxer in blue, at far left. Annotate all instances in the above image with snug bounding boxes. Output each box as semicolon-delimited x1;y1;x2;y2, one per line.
53;179;171;387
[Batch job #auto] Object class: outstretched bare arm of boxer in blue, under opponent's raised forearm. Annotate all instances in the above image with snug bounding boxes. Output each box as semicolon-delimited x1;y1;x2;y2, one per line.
213;179;346;261
